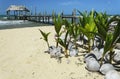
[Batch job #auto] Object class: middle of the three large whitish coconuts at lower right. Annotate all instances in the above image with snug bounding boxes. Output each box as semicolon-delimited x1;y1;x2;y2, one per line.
100;63;115;74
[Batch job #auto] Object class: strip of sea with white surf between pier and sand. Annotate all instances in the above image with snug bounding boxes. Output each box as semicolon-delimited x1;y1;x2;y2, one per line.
0;15;49;30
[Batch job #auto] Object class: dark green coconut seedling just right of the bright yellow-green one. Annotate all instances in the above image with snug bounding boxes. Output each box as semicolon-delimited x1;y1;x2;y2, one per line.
94;12;113;48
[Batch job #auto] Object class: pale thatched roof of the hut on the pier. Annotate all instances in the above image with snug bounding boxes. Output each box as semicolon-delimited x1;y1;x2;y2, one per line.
6;5;29;12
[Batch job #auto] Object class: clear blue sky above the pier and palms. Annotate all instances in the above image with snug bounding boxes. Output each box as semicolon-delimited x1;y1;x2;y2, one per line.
0;0;120;14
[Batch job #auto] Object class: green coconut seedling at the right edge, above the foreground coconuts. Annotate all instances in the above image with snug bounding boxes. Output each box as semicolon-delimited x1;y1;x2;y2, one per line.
101;20;120;64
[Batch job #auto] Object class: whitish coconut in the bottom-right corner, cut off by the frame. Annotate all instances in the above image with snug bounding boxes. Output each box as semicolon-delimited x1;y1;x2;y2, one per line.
104;70;120;79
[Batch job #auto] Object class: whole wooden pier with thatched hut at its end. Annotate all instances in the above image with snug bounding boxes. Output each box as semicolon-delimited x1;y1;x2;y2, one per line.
7;5;80;24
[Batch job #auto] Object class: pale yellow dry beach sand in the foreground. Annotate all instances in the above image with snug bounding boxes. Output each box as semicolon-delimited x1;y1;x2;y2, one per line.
0;26;104;79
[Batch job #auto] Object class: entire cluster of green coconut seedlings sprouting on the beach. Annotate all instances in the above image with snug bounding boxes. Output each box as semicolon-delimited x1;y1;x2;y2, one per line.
39;10;120;70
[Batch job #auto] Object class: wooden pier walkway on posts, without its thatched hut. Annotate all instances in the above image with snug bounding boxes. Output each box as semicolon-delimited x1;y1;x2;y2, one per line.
8;10;80;24
